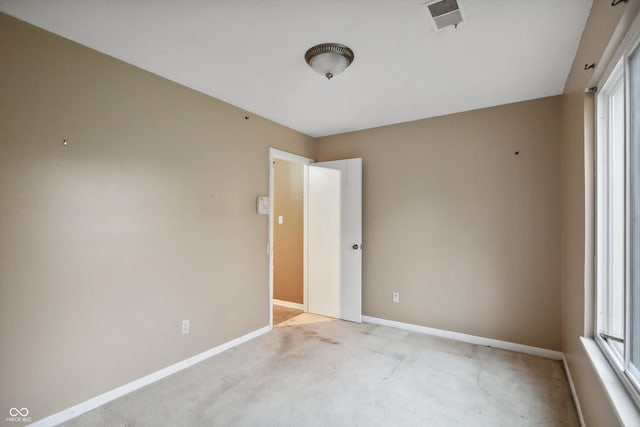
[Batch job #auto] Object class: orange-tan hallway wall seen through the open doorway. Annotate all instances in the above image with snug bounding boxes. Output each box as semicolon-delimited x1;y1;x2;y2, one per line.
273;159;304;304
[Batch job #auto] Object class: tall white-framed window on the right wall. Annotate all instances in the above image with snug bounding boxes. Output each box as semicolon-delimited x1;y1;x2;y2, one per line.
595;36;640;404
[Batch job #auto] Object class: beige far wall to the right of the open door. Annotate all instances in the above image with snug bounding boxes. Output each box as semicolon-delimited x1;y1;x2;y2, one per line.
316;97;560;350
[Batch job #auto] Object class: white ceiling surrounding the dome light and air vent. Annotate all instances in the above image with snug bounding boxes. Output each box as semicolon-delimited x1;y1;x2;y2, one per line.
0;0;592;137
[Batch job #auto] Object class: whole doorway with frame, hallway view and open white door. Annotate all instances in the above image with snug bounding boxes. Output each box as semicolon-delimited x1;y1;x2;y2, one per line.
269;148;362;327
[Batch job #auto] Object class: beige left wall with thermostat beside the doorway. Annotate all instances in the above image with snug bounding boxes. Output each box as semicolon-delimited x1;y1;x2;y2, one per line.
0;14;313;420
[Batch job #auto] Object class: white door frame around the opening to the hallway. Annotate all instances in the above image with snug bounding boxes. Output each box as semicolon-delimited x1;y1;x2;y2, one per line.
267;147;314;329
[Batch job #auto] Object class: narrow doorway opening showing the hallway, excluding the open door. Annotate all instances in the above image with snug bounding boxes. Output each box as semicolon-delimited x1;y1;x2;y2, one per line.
269;148;312;327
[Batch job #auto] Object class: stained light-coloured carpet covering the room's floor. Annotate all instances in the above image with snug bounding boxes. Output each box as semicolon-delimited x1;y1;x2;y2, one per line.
61;320;578;427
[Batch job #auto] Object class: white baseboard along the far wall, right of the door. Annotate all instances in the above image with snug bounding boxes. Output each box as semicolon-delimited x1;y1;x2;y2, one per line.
362;316;562;360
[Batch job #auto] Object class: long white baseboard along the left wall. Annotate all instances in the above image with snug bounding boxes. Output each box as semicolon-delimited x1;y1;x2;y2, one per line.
29;326;271;427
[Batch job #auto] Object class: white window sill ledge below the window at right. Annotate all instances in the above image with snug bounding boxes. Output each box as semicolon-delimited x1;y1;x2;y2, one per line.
580;337;640;426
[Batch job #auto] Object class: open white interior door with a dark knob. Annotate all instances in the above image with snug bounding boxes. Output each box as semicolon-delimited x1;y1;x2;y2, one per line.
307;159;362;322
